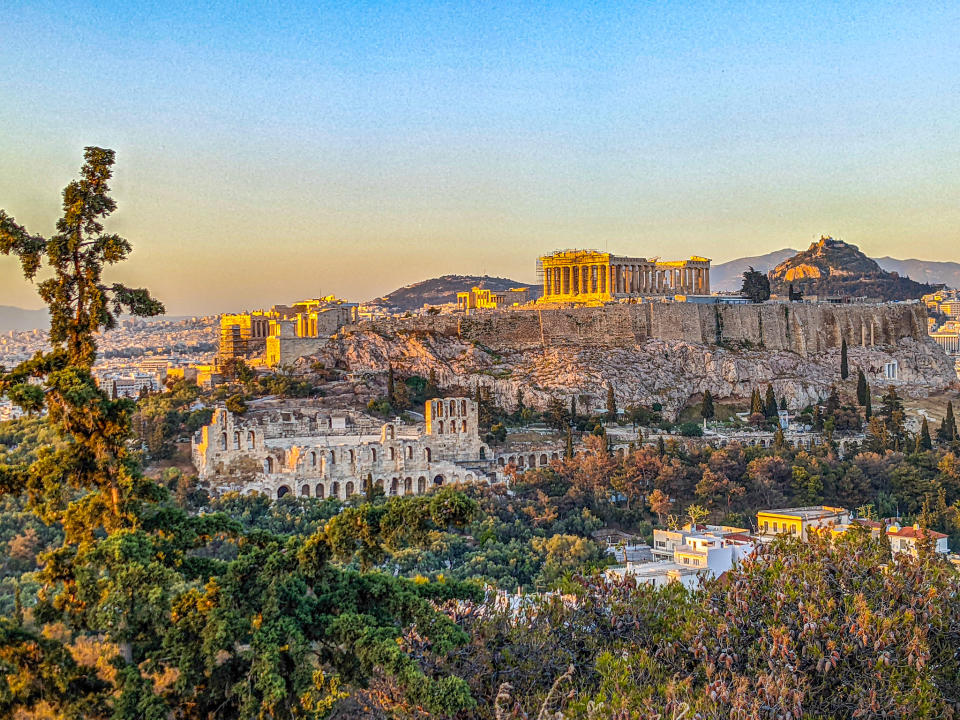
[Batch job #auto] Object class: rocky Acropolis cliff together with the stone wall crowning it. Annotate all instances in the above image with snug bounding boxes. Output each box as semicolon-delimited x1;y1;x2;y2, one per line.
300;302;956;420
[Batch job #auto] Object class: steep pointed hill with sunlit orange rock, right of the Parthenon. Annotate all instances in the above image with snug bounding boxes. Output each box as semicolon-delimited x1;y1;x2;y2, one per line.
769;237;933;300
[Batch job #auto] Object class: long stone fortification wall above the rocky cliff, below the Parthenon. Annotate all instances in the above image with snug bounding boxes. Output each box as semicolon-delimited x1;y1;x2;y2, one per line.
444;303;929;355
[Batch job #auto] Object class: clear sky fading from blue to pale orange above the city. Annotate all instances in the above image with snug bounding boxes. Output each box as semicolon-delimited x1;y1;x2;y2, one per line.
0;0;960;314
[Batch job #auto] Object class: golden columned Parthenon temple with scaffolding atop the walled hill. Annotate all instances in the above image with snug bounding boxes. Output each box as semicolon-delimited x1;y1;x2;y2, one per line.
540;250;710;302
